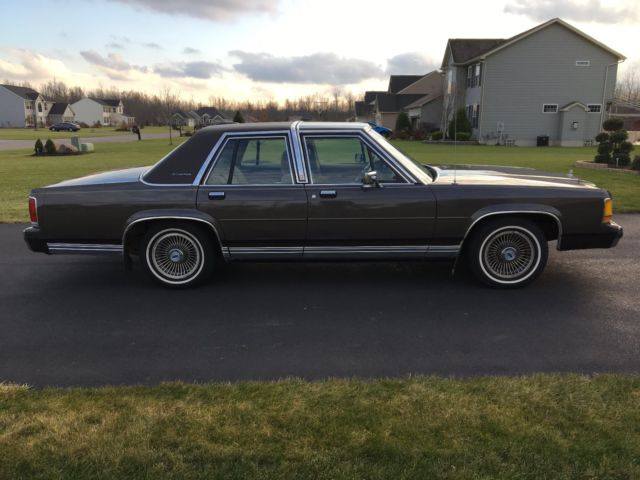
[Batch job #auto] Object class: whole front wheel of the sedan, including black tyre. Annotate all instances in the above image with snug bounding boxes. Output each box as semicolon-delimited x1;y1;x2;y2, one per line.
467;219;549;288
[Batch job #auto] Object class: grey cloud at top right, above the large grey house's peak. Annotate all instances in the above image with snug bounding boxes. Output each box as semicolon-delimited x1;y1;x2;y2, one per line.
504;0;640;24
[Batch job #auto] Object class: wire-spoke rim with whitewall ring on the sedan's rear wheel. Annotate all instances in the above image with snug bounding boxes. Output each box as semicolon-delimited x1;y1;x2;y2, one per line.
147;230;204;283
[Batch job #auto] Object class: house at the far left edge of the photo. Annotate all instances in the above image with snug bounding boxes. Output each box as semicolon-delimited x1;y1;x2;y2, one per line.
0;85;51;128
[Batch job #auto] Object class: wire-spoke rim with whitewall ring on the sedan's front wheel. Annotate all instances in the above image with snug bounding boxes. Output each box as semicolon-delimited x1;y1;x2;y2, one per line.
480;228;539;281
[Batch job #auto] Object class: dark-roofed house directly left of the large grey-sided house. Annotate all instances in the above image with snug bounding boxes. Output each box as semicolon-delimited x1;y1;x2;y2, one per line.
354;71;442;130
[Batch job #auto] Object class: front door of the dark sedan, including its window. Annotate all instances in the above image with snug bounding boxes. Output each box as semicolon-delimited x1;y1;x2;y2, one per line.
301;133;436;257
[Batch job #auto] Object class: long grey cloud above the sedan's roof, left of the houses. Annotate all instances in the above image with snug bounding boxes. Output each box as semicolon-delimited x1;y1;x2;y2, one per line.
229;50;384;85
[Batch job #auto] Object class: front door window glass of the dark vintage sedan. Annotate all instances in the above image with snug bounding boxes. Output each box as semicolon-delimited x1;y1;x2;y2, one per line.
305;137;404;184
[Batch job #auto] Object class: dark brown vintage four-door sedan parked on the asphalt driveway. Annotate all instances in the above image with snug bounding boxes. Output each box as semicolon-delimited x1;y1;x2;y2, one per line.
24;122;623;288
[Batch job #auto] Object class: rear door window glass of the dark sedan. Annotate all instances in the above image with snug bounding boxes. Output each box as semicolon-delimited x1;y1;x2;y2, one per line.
206;138;293;185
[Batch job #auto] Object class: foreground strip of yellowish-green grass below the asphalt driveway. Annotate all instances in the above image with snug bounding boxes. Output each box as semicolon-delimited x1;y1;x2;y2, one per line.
0;375;640;480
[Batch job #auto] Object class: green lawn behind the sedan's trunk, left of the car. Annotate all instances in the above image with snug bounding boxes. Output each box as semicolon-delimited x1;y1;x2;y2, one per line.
0;139;181;222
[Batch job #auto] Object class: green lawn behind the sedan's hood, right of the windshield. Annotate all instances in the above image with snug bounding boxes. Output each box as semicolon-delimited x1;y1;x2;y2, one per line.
393;141;640;213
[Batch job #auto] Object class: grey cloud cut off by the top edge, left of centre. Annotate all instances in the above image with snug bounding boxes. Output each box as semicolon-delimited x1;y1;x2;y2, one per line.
110;0;279;22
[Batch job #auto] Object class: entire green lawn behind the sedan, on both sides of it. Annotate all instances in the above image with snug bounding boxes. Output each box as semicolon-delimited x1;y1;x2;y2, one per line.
0;138;640;222
